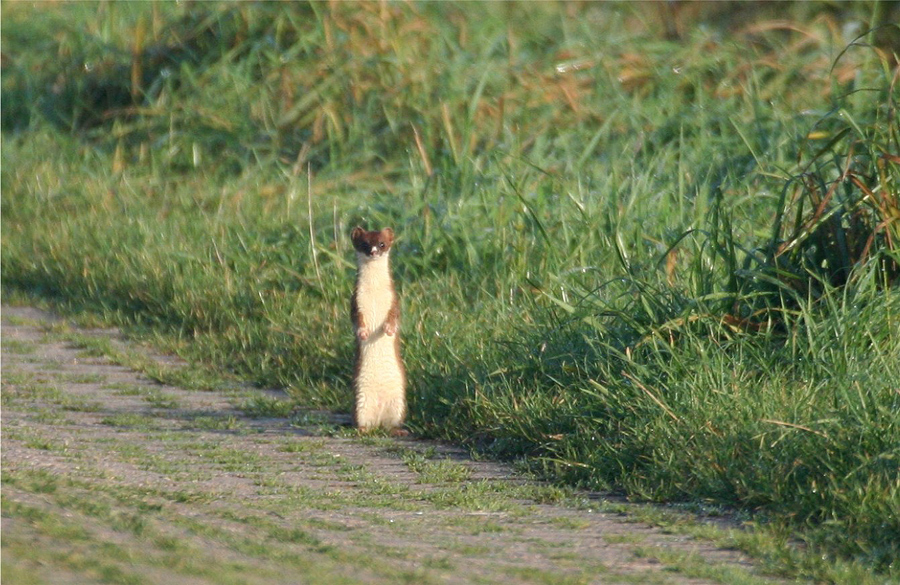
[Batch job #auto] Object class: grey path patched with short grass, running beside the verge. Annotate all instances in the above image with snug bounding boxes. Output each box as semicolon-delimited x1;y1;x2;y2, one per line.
2;307;780;585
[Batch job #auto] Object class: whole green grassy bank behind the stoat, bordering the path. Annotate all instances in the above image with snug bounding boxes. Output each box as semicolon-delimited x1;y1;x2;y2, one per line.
2;2;900;580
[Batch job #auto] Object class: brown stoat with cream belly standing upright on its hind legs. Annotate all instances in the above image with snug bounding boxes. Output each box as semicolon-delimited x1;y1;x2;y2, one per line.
350;227;406;432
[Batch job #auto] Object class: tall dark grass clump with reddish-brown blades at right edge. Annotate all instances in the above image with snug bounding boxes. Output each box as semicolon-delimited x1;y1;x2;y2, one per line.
729;52;900;326
